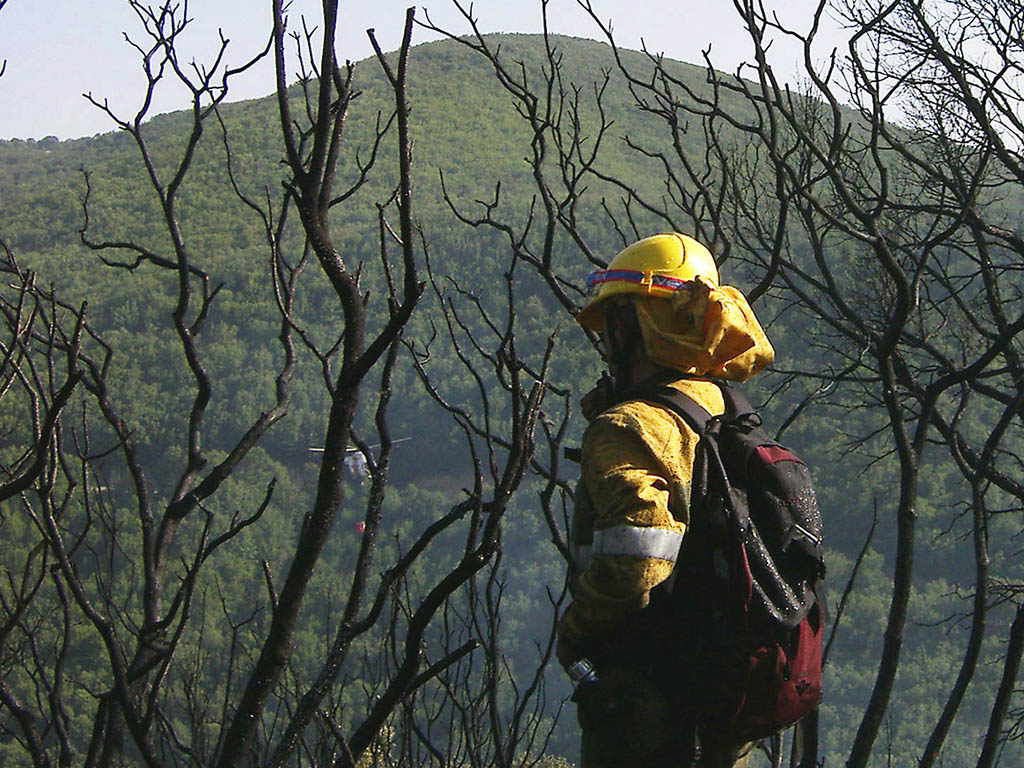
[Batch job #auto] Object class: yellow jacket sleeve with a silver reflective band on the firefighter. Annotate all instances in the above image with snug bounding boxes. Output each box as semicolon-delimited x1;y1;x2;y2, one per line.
559;401;696;646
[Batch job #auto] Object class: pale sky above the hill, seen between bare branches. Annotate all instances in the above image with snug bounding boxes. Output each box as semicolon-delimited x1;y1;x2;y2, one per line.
0;0;839;139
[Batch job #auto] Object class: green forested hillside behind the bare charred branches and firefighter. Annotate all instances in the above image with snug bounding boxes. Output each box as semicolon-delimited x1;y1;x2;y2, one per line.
0;4;1024;767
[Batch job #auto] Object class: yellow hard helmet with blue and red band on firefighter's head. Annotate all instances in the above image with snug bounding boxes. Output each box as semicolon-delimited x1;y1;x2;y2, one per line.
577;232;718;331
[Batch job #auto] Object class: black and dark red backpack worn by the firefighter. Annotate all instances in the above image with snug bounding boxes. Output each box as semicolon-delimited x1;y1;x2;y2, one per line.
634;384;825;741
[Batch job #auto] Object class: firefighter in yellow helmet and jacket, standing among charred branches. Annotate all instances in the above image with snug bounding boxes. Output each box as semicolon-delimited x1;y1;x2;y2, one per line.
556;232;773;768
